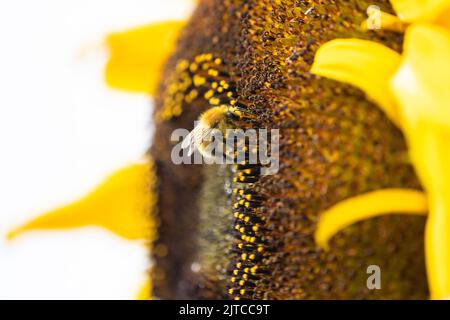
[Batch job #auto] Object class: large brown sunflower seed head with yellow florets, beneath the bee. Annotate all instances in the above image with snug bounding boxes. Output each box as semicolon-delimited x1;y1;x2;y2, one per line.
151;0;426;299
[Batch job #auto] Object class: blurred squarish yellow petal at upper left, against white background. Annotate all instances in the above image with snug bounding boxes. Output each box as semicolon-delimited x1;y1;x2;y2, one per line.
105;21;185;94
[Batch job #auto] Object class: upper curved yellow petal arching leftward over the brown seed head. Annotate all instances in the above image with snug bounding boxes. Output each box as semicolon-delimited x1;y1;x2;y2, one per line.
311;39;400;126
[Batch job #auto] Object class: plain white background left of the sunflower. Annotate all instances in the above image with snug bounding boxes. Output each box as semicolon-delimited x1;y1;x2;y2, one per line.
0;0;192;299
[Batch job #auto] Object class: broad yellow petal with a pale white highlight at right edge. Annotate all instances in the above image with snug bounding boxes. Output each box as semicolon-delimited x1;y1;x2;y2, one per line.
392;25;450;127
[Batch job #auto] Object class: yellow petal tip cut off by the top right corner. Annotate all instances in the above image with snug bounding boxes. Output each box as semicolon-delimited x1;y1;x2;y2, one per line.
391;0;450;22
